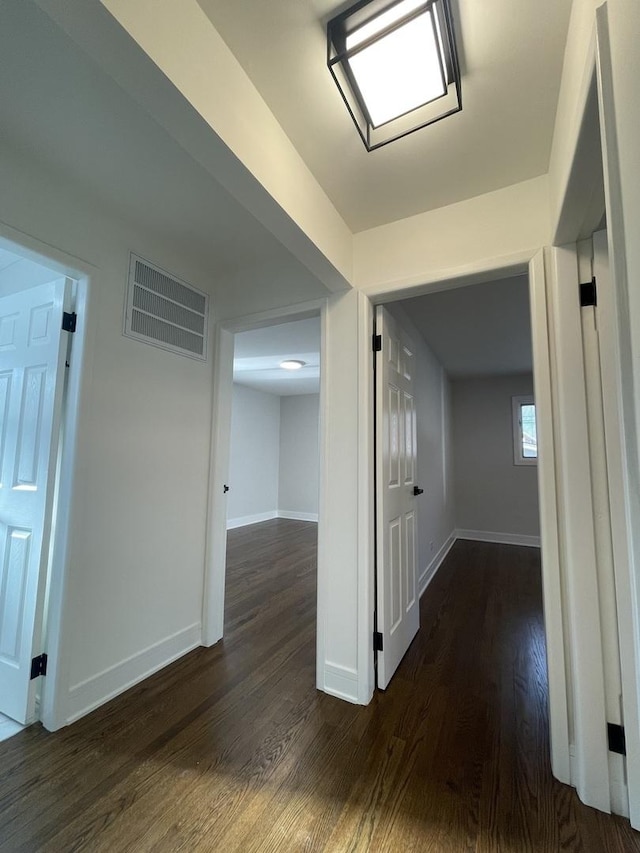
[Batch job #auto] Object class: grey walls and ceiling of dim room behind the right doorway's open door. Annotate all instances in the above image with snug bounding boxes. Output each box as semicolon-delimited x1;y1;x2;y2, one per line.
386;275;540;580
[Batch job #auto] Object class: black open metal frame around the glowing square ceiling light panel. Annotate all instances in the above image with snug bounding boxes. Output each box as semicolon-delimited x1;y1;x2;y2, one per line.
327;0;462;151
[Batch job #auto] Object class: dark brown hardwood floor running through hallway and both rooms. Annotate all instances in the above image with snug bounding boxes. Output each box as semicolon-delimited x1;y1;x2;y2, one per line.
0;520;640;853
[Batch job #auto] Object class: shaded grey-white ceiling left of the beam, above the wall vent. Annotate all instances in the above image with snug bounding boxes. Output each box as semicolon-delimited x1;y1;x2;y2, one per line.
0;0;327;316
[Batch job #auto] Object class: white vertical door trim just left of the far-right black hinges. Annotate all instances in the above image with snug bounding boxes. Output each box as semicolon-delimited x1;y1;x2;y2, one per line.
548;243;611;812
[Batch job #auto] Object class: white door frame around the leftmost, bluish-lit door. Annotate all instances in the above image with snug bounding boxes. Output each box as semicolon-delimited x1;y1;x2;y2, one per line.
0;216;98;731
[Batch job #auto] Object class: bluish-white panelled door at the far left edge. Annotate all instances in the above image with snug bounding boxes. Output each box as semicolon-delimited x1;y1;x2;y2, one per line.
0;279;69;723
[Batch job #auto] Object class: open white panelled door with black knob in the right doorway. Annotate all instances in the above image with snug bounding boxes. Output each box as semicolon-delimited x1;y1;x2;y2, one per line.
376;306;420;689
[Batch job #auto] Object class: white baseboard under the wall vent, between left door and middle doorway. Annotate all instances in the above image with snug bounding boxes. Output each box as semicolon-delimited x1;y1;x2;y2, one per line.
66;622;201;723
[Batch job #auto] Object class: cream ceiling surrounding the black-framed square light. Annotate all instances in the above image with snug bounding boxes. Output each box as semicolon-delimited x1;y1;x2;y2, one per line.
198;0;571;232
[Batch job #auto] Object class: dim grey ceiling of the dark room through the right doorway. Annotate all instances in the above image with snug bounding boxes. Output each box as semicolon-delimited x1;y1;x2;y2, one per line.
400;275;533;379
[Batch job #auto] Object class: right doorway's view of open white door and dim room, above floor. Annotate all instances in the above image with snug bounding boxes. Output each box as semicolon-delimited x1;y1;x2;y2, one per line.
376;274;540;688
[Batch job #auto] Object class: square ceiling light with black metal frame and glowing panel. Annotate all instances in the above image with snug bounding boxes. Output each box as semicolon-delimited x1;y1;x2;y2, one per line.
327;0;462;151
